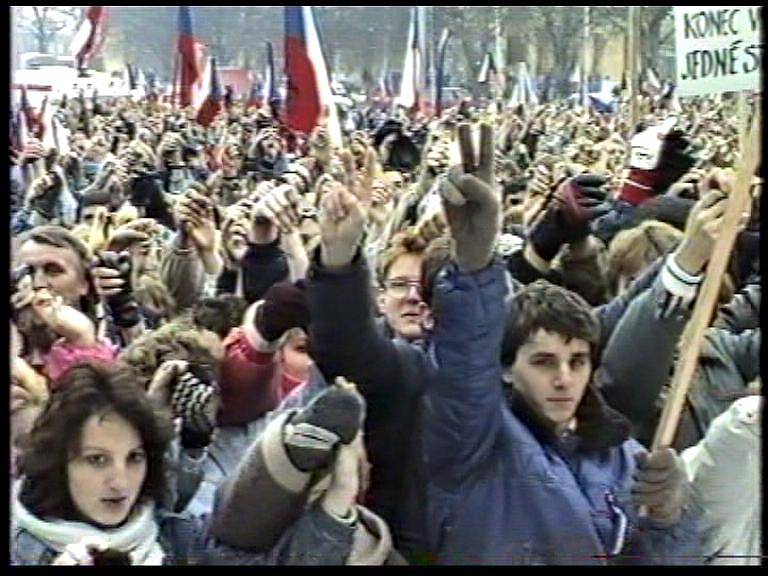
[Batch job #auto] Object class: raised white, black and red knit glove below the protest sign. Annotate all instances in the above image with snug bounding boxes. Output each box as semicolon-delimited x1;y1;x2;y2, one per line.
619;118;696;206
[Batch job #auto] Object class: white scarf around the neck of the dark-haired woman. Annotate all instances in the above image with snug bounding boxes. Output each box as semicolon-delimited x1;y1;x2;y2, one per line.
13;482;165;566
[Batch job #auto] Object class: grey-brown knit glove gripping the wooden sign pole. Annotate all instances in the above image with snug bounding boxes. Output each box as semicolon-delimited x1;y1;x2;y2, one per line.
632;448;689;527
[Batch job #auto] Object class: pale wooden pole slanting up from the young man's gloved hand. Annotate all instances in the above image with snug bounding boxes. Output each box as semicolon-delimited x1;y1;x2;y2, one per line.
652;108;761;450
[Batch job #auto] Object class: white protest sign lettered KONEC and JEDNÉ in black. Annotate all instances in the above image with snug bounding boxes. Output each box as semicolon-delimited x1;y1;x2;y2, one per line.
674;6;763;96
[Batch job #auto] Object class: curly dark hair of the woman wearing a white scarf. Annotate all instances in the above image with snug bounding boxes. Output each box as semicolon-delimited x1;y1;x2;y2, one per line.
19;362;173;520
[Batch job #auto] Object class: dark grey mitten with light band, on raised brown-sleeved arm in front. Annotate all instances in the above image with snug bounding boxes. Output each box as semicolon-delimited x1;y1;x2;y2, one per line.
284;386;365;472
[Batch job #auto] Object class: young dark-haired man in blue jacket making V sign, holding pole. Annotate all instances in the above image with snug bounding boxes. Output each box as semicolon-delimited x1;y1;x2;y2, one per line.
423;122;702;564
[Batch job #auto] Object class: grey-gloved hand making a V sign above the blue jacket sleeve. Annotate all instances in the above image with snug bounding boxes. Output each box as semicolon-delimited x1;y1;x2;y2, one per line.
440;124;501;272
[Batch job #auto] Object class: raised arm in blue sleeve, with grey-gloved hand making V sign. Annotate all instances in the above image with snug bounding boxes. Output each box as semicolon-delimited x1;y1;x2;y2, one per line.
424;125;506;490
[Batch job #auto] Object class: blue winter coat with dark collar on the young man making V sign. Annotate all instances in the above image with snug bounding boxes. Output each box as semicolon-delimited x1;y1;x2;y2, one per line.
424;266;701;564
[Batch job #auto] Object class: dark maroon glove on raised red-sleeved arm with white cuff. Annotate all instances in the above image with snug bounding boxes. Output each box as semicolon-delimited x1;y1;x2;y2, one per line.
256;282;310;342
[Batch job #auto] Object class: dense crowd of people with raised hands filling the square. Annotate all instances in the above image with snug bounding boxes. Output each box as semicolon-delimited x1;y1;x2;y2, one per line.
10;82;762;565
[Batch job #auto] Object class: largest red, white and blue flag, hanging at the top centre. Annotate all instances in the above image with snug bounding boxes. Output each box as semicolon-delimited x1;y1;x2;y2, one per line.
285;6;342;146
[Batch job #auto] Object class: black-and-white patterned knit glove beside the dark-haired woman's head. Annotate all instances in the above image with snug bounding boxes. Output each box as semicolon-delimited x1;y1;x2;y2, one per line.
171;366;219;449
